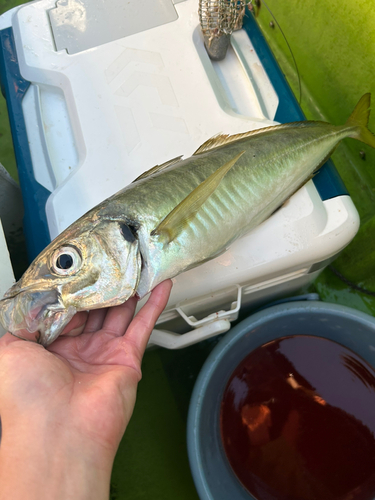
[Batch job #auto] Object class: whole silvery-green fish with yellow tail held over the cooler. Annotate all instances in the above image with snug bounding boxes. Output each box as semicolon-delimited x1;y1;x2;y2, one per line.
0;94;375;346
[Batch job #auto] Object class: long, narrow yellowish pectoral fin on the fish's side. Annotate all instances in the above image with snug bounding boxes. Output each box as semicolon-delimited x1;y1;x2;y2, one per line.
151;151;245;242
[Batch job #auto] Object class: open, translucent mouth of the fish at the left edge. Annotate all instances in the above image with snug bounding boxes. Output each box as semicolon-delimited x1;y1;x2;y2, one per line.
0;285;76;347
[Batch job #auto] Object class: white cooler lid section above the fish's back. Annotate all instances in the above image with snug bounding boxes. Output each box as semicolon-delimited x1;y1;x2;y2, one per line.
13;0;278;238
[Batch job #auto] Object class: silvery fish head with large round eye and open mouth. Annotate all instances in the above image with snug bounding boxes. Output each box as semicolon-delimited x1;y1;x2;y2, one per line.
0;217;141;346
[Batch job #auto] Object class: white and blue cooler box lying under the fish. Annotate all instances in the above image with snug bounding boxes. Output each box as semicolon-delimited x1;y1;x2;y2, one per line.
0;0;359;348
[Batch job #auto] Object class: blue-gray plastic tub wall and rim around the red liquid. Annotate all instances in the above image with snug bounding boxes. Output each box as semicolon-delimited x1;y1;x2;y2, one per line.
187;302;375;500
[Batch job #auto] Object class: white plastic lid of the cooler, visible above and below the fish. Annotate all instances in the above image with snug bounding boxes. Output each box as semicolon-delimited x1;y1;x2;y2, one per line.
0;0;359;348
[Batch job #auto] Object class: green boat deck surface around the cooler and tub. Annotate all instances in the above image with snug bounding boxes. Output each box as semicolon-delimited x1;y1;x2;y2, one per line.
0;0;375;500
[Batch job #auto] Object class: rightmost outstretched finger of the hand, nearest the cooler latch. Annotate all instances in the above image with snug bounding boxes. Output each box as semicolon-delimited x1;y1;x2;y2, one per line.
124;280;172;359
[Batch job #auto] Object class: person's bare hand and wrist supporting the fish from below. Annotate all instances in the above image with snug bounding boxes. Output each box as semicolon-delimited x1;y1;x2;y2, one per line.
0;280;172;500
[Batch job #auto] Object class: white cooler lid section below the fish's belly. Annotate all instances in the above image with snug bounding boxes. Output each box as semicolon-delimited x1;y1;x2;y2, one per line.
162;190;359;307
